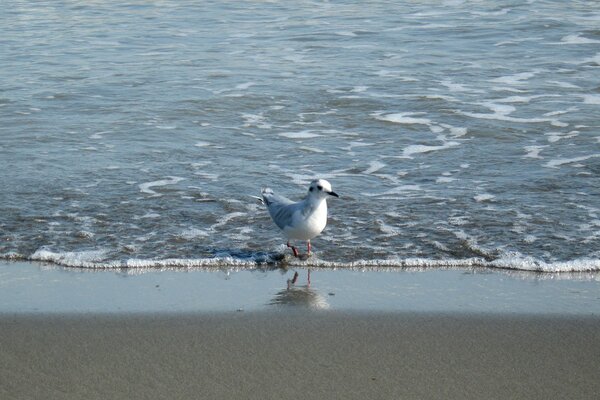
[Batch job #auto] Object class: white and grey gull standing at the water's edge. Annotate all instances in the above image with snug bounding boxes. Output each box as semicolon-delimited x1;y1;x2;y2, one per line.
261;179;340;257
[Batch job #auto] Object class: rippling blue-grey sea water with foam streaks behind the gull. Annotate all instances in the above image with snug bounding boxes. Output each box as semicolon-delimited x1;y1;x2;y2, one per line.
0;1;600;272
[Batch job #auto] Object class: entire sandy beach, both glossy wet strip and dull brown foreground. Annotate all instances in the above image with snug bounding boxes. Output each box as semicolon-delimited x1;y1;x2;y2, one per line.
0;262;600;399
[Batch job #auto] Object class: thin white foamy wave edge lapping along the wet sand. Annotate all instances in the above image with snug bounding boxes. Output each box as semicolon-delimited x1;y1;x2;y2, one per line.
0;248;600;274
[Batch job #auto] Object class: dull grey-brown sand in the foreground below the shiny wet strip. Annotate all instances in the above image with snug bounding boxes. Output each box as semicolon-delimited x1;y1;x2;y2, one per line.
0;310;600;399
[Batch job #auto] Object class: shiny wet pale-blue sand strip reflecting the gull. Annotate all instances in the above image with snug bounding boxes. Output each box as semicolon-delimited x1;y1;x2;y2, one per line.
0;262;600;316
